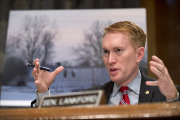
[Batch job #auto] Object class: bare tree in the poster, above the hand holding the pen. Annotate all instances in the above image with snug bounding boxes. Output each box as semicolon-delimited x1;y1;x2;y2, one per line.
6;16;55;65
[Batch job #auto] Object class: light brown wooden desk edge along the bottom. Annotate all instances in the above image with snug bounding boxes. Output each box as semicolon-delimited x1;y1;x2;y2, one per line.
0;102;180;120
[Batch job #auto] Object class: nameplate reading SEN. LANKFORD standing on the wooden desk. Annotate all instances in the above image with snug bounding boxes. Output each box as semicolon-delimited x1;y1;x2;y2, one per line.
39;90;105;107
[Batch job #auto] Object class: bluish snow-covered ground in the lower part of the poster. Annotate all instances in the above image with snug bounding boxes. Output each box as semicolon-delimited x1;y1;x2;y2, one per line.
0;68;109;107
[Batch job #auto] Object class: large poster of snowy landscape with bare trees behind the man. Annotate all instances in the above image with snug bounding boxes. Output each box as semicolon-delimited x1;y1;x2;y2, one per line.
0;9;147;106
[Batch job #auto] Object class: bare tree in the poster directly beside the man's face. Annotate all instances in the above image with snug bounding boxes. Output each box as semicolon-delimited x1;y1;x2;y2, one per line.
74;21;110;67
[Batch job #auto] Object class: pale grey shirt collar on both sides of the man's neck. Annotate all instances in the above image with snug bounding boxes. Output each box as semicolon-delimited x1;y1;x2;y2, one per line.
112;70;141;96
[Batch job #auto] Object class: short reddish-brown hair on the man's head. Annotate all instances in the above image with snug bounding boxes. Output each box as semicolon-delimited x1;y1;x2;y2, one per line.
104;21;146;47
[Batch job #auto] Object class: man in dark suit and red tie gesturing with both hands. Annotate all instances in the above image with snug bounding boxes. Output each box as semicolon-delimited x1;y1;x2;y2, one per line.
32;21;179;105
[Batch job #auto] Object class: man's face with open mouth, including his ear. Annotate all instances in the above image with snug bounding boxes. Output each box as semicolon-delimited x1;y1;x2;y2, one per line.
102;32;144;85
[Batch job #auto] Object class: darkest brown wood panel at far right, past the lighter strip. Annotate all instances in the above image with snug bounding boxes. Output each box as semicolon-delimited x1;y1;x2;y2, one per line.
155;0;180;85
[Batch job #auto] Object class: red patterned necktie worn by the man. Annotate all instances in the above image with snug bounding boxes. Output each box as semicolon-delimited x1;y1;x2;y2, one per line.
119;86;130;104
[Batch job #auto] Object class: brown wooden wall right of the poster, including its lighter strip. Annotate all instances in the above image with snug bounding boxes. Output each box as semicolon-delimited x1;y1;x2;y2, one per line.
141;0;180;85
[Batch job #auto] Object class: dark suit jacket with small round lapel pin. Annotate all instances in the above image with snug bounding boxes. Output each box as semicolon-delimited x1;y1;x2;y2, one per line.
102;74;180;103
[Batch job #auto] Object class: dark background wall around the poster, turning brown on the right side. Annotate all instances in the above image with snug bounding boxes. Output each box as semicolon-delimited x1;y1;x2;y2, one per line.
0;0;180;95
